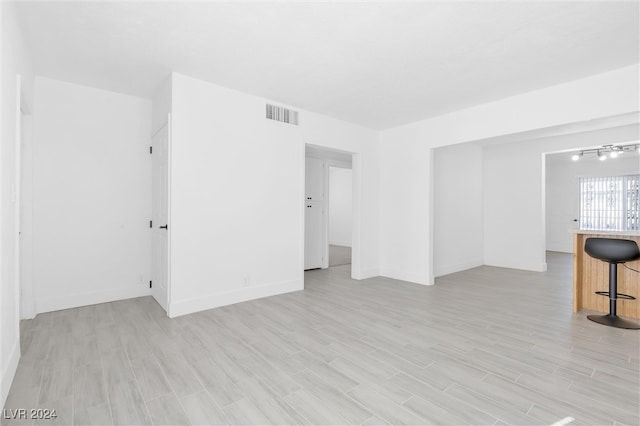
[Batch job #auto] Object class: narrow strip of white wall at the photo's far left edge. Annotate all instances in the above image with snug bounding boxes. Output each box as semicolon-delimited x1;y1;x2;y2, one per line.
0;2;33;406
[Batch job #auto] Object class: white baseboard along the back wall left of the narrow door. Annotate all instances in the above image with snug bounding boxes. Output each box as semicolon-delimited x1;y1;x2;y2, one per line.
37;285;151;314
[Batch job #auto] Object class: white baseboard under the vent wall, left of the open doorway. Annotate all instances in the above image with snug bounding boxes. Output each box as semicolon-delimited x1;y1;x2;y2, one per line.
169;280;304;318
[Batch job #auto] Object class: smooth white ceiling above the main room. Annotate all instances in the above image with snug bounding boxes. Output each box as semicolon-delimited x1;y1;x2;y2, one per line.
17;1;640;129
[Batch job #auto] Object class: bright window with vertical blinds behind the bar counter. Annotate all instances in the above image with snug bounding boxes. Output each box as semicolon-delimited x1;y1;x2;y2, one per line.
580;175;640;231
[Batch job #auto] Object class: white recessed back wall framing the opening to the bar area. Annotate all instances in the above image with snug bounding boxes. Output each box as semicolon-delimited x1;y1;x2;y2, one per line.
483;125;639;271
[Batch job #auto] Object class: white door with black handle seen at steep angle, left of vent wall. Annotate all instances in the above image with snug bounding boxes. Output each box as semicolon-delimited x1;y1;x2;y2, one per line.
151;124;169;311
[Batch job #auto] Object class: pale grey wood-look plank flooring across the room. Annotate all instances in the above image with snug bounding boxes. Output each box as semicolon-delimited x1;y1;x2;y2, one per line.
3;253;640;425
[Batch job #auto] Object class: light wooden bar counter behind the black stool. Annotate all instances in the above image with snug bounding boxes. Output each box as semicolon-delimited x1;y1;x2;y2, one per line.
570;229;640;319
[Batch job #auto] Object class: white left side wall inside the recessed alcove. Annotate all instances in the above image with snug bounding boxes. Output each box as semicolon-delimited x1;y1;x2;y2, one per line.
433;143;484;277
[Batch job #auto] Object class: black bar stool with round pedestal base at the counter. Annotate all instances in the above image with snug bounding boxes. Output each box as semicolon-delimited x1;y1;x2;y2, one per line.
584;238;640;330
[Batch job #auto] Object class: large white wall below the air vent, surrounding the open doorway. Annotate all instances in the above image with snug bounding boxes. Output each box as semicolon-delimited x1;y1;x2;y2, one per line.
169;74;378;316
